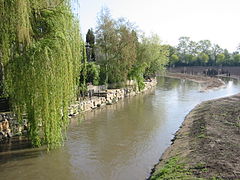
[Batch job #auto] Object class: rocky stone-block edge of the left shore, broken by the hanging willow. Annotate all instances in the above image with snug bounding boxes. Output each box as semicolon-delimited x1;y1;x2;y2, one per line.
0;78;157;148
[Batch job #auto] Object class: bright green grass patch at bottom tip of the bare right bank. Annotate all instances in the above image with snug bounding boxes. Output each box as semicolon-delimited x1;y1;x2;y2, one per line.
151;156;203;180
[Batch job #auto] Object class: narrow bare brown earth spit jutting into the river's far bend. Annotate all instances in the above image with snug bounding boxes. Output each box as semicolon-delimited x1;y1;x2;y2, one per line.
164;72;225;91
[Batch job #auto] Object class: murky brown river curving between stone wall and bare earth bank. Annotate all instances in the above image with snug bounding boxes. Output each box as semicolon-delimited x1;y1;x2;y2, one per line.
0;77;240;180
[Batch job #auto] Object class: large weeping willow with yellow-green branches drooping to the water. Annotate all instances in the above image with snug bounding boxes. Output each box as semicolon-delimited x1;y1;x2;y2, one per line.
0;0;84;148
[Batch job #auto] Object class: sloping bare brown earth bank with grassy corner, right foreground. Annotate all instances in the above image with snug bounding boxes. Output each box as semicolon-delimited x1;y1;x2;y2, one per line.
149;88;240;177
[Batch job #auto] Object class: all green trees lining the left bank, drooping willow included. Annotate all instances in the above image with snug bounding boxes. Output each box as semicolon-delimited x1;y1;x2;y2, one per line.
0;0;168;149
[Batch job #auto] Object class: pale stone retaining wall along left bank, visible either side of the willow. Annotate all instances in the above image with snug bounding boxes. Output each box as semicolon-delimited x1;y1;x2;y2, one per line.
0;79;157;141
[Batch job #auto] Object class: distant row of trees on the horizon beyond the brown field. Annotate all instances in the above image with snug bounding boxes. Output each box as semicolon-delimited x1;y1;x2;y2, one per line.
168;37;240;67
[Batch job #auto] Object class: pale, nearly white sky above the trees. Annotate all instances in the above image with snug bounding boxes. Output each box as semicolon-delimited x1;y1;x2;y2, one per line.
76;0;240;51
